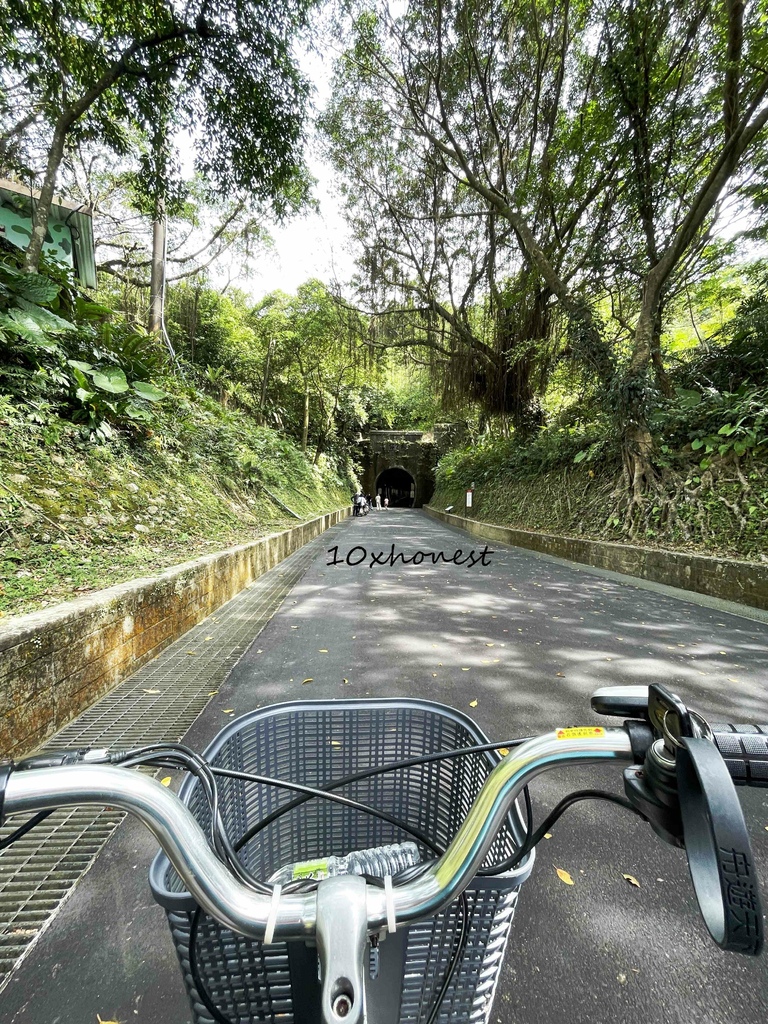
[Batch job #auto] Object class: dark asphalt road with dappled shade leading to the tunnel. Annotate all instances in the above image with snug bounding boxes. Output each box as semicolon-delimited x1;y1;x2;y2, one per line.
0;510;768;1024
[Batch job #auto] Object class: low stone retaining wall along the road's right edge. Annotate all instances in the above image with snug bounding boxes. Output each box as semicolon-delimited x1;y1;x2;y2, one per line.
424;505;768;608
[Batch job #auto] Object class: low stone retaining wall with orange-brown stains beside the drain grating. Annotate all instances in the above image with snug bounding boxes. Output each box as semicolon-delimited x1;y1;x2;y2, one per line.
0;508;349;757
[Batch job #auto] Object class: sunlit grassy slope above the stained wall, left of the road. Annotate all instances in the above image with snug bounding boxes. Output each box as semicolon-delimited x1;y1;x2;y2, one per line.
0;380;349;616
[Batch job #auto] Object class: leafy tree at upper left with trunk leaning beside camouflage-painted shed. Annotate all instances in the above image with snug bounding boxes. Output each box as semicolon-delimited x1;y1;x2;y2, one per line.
0;0;311;270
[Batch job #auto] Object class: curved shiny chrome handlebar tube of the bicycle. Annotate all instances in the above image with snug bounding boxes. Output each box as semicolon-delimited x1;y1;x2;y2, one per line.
4;728;633;939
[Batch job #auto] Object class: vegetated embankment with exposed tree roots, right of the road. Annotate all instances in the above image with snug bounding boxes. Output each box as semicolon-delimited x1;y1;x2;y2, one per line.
431;447;768;561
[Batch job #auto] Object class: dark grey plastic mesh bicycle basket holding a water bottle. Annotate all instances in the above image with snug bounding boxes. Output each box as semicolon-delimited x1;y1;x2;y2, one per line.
150;699;532;1024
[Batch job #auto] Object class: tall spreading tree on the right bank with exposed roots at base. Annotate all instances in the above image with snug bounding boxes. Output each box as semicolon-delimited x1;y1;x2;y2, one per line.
327;0;768;501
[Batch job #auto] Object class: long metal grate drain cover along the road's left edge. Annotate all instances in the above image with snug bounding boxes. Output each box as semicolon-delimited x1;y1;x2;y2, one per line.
0;539;327;991
